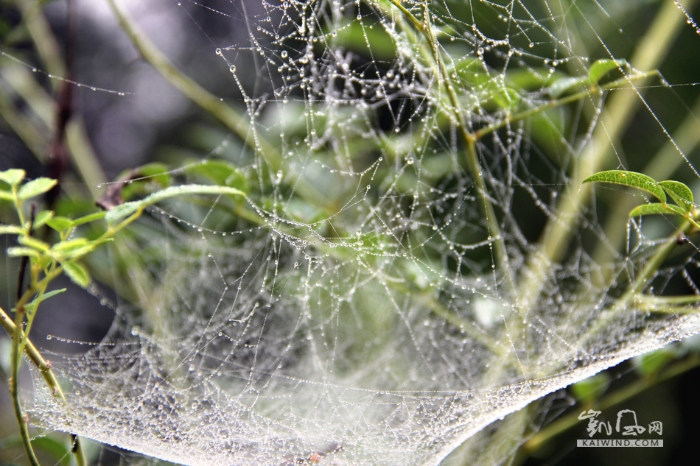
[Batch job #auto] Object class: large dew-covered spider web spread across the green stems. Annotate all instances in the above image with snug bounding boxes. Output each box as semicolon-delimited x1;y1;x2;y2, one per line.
21;0;700;465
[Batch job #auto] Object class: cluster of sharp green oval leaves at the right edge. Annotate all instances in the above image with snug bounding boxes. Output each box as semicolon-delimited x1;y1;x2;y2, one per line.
583;170;700;230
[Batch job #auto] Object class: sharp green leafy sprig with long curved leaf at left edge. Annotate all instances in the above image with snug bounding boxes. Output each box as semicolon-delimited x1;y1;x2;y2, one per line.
0;164;247;465
